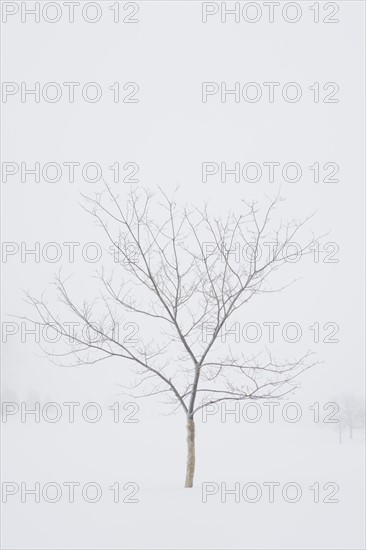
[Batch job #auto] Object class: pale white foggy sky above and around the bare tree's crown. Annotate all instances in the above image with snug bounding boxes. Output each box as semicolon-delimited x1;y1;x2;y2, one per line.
2;2;364;406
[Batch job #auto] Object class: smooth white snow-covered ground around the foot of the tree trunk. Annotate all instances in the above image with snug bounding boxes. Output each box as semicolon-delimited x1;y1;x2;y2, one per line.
2;406;365;550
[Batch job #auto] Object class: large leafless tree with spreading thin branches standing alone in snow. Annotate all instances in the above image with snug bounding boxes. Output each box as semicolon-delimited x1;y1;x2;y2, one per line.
23;188;315;487
